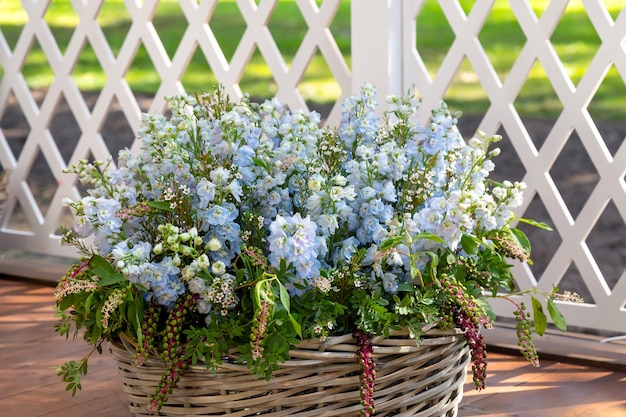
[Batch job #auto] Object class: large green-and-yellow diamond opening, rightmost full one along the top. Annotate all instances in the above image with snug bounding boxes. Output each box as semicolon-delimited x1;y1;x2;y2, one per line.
550;1;601;85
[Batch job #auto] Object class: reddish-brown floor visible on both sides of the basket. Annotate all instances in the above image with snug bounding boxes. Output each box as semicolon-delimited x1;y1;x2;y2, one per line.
0;279;626;417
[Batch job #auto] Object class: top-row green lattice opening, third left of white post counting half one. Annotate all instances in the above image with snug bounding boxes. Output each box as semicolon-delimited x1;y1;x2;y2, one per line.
211;1;247;62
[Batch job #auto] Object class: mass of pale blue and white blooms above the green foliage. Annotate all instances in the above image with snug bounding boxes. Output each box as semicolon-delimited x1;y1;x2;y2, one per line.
63;85;524;314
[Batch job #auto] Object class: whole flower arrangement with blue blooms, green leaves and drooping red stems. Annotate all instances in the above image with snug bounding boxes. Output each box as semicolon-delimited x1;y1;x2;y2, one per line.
55;85;565;415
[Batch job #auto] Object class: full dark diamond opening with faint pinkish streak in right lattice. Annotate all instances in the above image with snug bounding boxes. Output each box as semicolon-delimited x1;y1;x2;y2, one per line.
550;131;600;218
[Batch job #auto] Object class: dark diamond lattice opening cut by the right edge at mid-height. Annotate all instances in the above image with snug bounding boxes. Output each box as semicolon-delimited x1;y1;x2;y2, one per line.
585;200;626;289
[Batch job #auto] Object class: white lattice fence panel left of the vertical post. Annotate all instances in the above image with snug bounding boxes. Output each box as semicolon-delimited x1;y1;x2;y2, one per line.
0;0;352;257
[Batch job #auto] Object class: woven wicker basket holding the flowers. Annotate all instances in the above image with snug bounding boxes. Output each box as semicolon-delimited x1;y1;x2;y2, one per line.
111;330;470;417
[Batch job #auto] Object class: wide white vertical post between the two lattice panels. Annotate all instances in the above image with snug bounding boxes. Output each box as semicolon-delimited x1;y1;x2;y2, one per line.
351;0;404;100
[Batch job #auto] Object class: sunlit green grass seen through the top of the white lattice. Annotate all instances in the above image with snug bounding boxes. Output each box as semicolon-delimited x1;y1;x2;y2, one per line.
0;0;626;119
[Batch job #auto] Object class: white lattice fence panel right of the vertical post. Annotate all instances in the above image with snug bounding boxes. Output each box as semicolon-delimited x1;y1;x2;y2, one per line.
402;0;626;332
